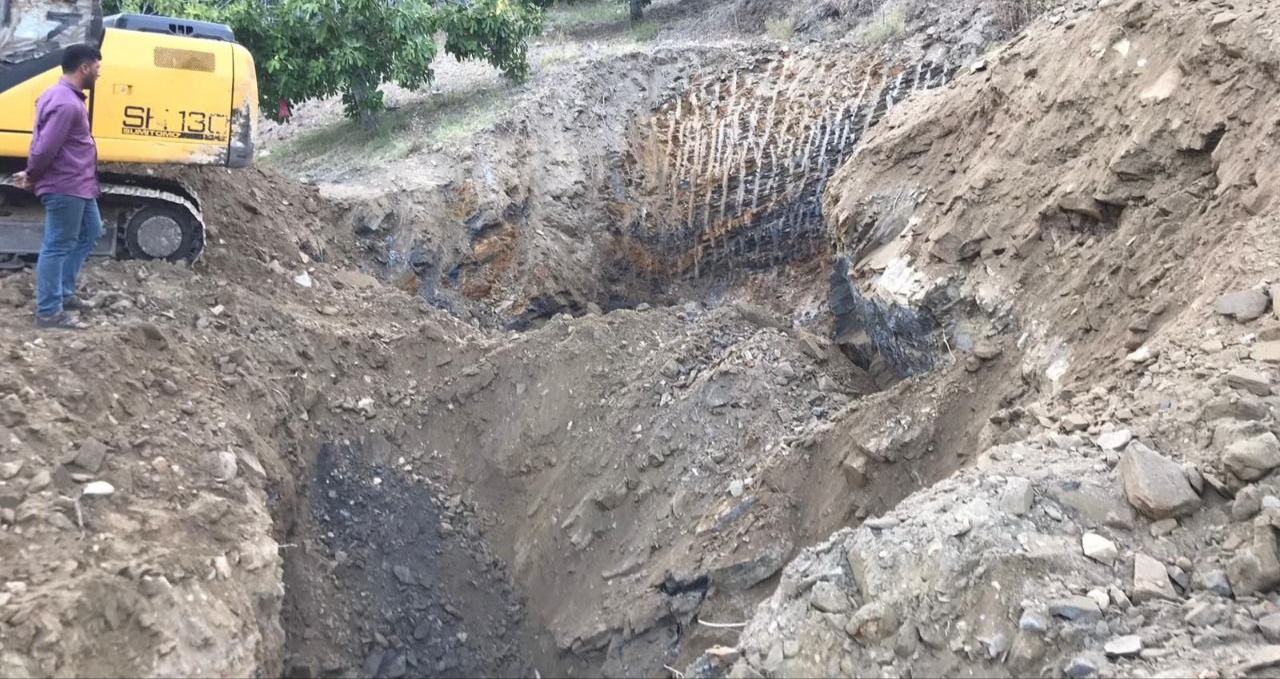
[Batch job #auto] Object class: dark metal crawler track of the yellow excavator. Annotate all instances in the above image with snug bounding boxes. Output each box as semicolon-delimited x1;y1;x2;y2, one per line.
0;173;205;268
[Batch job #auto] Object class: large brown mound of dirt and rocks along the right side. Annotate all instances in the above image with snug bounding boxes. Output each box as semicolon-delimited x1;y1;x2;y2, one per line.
691;1;1280;676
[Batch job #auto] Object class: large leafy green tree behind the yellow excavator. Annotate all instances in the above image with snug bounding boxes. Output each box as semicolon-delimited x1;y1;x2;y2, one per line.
104;0;541;124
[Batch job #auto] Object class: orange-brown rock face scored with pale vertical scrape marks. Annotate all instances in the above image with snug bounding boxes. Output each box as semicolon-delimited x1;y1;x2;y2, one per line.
614;50;955;279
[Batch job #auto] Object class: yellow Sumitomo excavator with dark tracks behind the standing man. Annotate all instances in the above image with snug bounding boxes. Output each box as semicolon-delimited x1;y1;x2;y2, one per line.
0;0;257;265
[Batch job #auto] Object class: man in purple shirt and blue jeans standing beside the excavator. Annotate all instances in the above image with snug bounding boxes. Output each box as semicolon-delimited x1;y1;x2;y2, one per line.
17;45;102;328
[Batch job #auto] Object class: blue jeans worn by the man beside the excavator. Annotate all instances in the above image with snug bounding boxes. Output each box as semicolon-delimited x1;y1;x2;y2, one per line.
36;193;102;316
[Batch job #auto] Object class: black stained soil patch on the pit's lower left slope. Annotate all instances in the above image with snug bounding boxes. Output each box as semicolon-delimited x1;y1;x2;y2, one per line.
284;445;557;679
